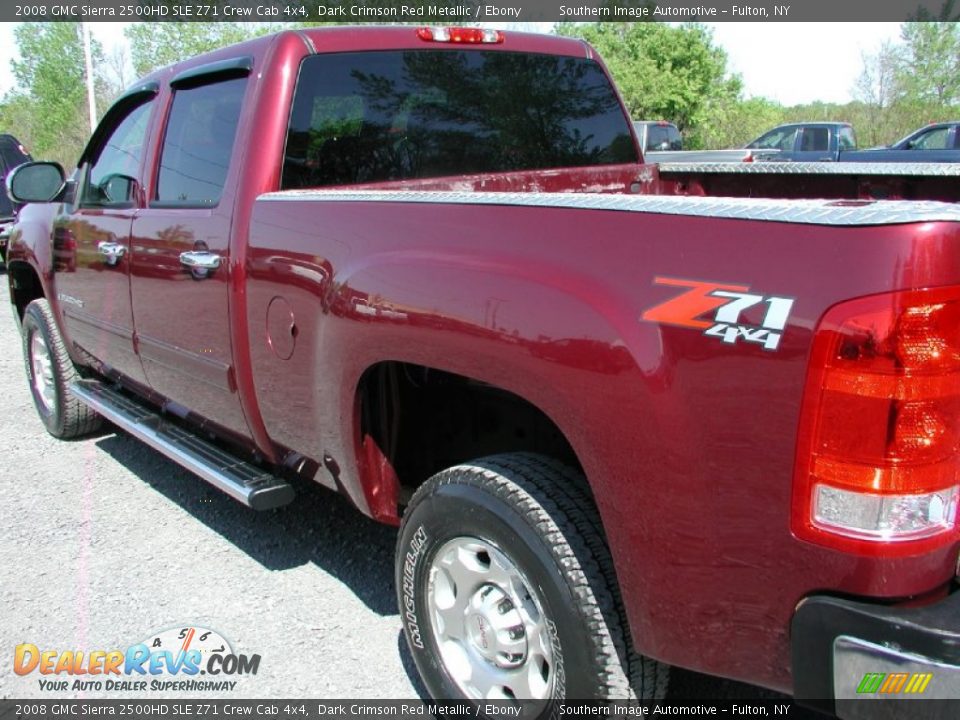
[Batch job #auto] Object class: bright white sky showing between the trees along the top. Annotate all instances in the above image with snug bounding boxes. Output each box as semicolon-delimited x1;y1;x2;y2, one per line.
0;22;900;105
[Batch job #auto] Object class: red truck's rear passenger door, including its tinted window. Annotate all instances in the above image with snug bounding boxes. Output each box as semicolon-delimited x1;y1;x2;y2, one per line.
131;58;252;435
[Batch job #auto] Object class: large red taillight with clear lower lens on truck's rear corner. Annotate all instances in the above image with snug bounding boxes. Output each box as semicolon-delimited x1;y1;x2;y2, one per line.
793;287;960;555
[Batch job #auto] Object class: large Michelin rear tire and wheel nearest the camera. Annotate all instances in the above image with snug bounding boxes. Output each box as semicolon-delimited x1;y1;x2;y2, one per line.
396;453;669;702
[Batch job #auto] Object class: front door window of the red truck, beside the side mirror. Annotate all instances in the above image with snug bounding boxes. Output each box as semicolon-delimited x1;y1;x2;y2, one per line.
80;102;153;205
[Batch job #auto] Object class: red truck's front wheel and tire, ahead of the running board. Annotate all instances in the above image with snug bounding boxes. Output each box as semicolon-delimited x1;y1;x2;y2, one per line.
23;298;103;439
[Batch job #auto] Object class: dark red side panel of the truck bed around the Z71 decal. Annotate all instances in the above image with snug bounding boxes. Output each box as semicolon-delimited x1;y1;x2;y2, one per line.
247;194;960;688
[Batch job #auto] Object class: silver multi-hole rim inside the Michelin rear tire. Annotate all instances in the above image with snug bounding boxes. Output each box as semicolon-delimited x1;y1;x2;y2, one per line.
427;537;556;700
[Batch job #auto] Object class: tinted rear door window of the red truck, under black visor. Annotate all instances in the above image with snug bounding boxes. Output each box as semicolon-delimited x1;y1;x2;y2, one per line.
155;78;247;207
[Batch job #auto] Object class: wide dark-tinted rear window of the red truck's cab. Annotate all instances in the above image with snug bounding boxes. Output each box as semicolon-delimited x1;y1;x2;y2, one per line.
283;50;638;188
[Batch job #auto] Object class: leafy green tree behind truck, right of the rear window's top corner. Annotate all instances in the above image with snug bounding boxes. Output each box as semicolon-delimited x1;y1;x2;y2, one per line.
556;22;742;145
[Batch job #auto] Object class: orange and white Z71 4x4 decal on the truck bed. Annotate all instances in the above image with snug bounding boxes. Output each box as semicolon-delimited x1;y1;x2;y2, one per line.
641;277;793;350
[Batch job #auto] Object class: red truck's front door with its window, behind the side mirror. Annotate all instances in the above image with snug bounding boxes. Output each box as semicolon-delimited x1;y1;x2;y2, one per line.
53;85;157;383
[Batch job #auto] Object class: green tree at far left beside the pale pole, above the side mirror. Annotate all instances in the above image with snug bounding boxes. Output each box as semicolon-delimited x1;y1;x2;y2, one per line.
0;22;103;167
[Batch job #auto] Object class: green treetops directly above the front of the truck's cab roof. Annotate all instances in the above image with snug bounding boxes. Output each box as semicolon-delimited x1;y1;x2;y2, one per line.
123;22;280;76
